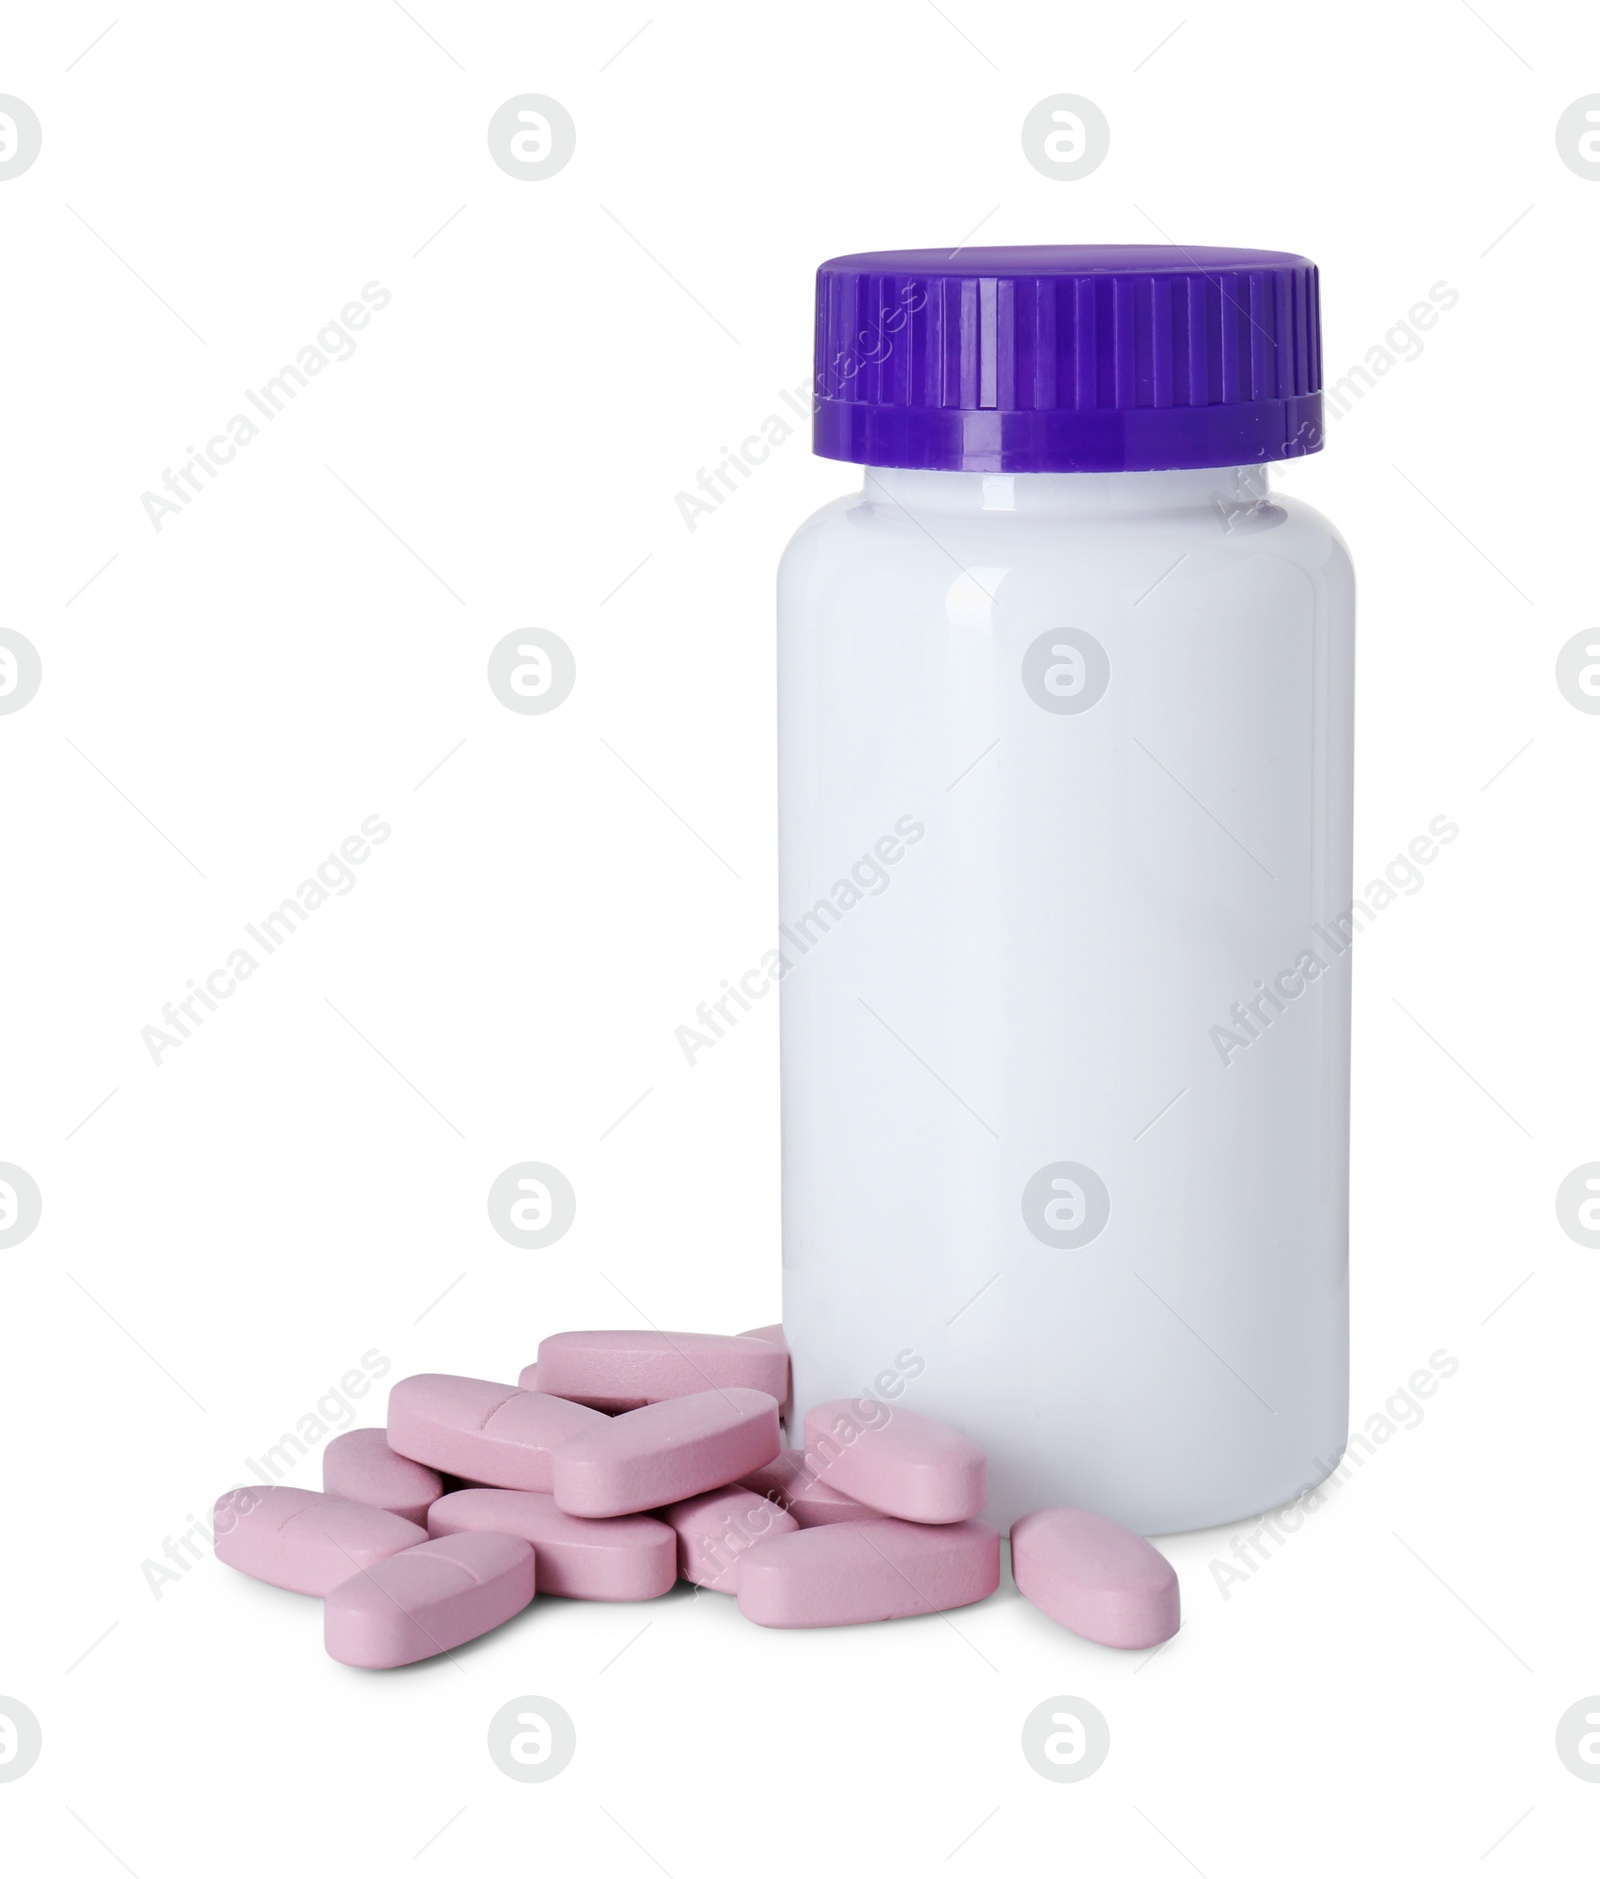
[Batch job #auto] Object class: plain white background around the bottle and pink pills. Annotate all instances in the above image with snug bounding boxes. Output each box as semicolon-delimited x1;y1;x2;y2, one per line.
0;0;1600;1879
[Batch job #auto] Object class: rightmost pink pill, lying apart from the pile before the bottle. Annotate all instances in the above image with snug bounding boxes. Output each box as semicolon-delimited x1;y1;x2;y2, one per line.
1010;1507;1177;1650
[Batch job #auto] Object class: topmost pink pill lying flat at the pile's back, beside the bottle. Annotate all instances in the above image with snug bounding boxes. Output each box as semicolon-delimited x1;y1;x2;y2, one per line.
539;1330;789;1409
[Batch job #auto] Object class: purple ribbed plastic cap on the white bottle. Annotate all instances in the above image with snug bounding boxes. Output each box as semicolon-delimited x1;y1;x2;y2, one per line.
813;246;1322;474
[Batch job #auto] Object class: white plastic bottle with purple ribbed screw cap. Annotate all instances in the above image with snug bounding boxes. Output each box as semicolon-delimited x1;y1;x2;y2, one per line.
779;248;1354;1533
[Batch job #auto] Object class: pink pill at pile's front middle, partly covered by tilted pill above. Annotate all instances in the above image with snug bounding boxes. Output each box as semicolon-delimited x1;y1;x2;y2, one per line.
428;1488;678;1599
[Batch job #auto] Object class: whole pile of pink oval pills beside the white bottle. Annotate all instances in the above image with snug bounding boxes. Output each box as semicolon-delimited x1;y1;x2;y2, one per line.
216;1327;1177;1670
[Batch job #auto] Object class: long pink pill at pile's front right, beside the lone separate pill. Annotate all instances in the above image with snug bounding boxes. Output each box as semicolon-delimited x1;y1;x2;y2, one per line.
738;1520;999;1629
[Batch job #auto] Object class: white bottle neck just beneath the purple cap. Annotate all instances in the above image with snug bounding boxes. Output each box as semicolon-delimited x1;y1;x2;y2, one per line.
862;464;1269;517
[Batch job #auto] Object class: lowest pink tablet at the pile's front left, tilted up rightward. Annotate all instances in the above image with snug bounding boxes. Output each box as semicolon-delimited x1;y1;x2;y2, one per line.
323;1533;533;1670
